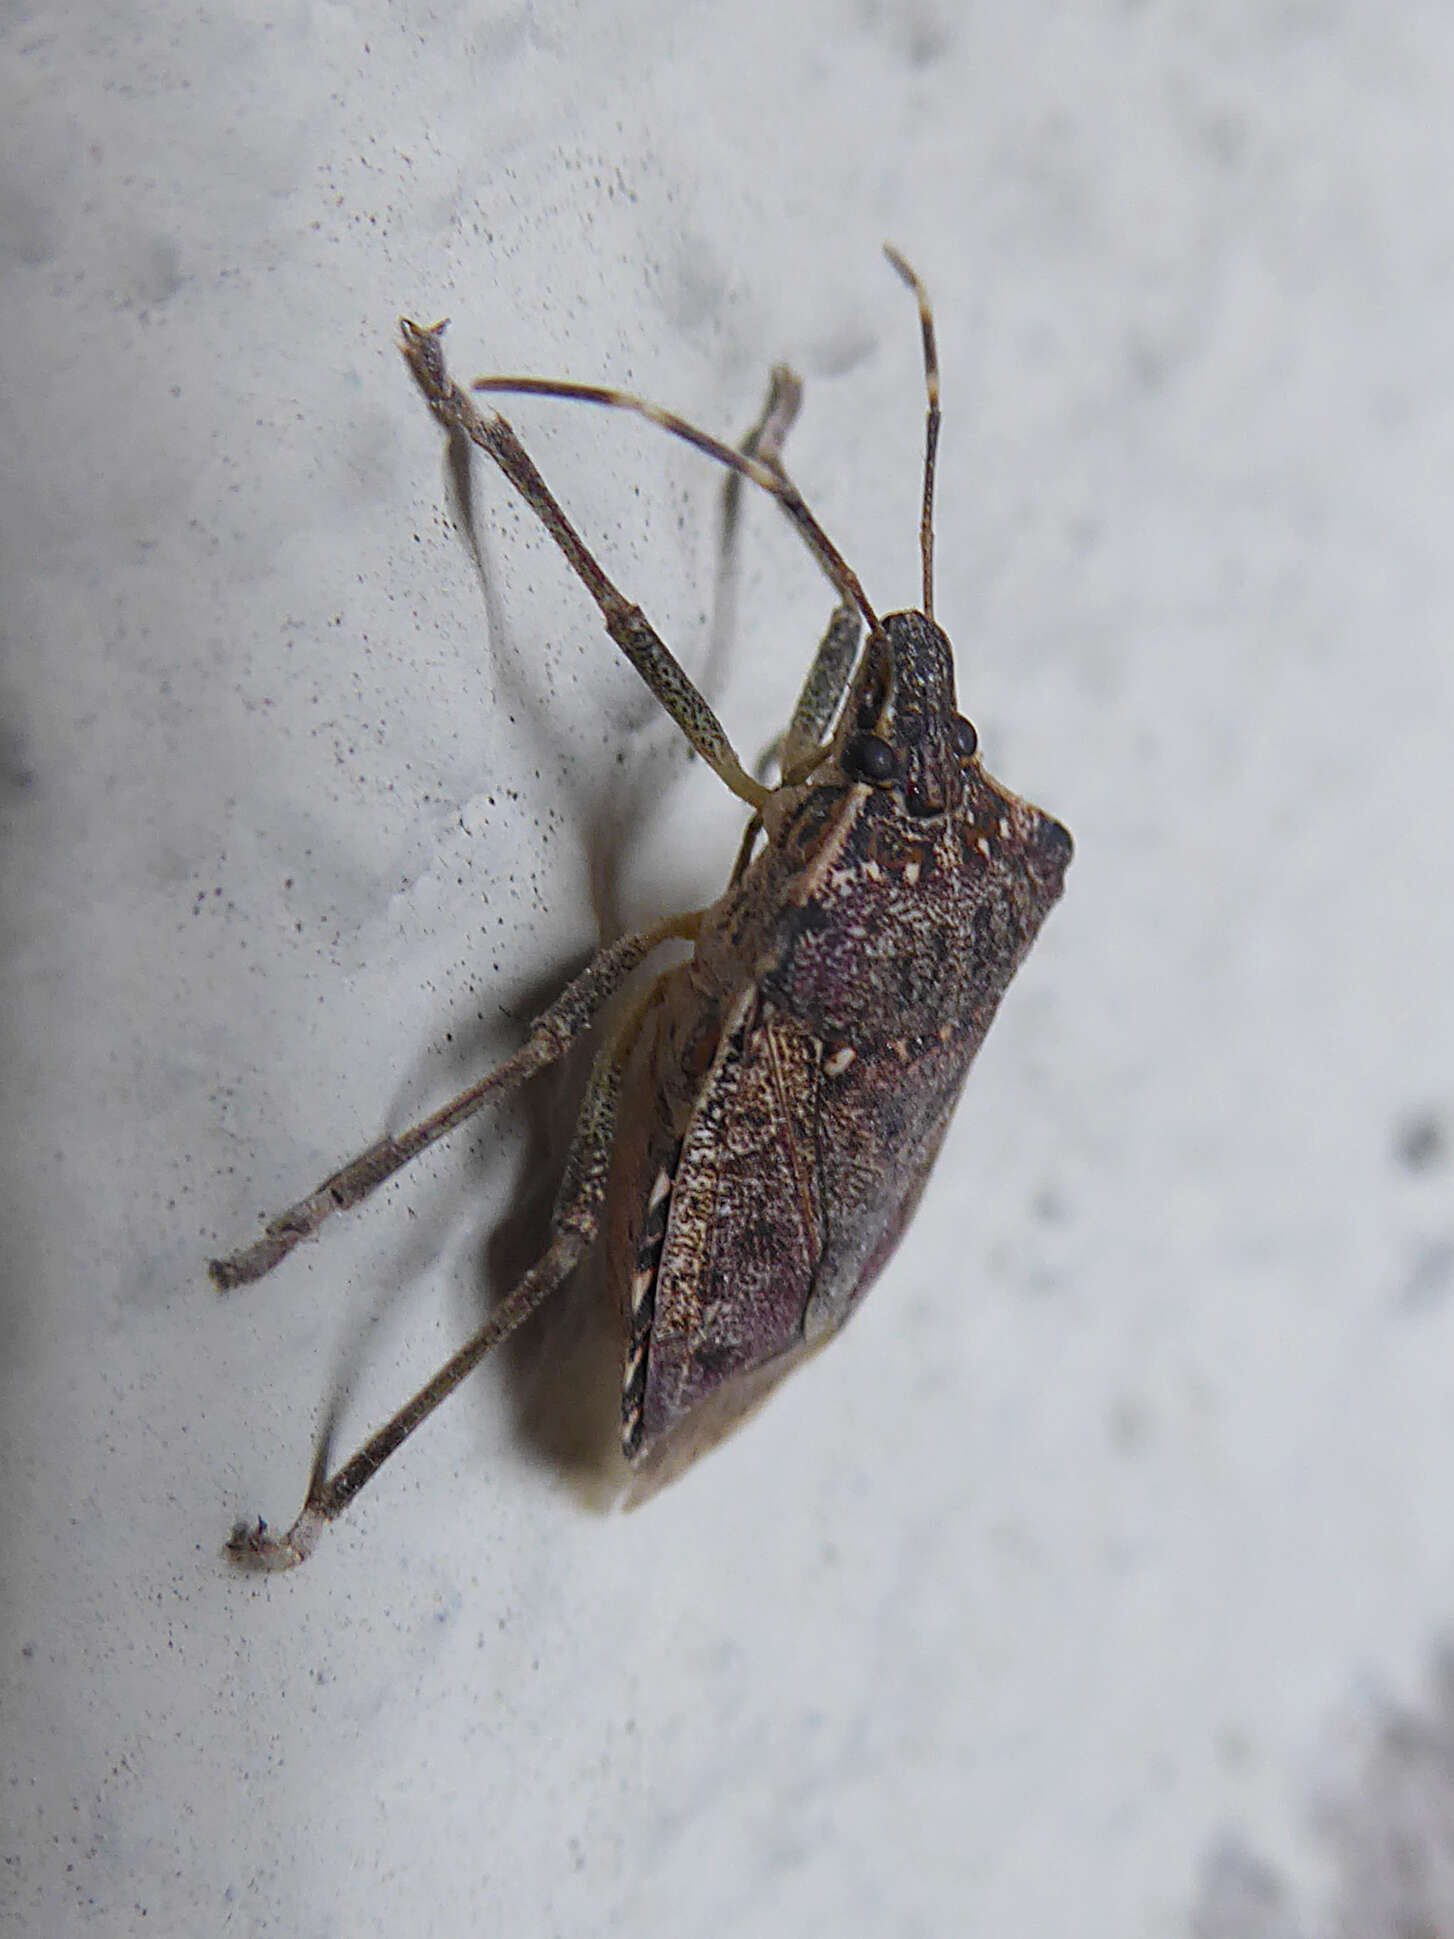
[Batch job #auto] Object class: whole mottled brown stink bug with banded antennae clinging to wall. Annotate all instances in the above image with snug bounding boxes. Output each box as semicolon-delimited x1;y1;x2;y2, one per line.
211;250;1072;1569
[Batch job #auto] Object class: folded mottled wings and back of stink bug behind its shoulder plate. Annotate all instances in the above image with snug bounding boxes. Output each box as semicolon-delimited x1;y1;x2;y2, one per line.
622;991;964;1507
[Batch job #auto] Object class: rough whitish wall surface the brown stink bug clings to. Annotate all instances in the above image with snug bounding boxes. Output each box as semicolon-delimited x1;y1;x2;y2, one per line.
0;0;1454;1939
